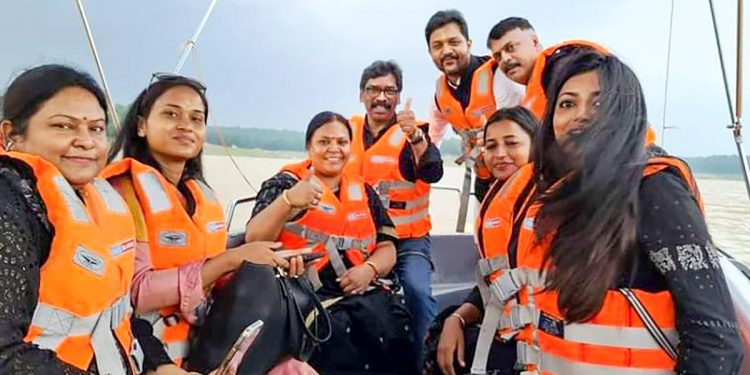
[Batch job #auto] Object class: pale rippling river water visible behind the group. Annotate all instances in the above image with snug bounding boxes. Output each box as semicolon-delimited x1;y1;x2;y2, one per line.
204;156;750;264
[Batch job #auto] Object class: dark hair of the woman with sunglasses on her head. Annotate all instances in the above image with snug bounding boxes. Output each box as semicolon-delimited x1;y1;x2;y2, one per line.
107;76;208;182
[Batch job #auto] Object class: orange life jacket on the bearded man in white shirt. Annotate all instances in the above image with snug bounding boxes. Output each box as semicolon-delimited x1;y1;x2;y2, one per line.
435;58;497;179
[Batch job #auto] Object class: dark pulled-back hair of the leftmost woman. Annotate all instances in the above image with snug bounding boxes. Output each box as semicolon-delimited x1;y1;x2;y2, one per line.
2;64;109;135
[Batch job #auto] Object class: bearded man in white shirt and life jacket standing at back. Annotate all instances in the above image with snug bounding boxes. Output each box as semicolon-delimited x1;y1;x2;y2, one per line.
425;10;523;226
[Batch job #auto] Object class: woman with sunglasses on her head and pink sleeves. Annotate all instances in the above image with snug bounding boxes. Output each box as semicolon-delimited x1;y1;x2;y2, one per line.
102;74;303;370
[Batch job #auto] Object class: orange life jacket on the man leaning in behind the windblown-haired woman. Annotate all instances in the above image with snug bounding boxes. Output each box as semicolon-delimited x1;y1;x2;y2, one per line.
523;40;656;145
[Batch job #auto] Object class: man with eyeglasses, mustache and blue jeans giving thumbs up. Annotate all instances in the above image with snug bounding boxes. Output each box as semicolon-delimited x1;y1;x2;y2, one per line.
347;61;443;371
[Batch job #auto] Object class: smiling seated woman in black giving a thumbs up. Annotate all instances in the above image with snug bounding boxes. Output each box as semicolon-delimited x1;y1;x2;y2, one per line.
246;111;416;374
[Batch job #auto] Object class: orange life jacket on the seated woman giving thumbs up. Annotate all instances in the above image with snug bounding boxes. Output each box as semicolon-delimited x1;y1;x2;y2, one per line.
279;160;377;275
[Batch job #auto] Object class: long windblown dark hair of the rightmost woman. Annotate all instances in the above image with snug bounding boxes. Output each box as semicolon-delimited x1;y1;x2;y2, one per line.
534;51;647;322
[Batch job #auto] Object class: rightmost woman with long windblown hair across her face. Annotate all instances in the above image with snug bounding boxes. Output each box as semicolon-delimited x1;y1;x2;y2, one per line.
472;51;743;375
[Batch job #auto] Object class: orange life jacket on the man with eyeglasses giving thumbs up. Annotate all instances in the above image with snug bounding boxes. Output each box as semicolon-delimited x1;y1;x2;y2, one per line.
346;116;432;238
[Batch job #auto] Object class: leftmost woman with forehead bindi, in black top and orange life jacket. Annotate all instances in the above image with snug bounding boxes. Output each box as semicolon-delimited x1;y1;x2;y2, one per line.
0;65;200;375
